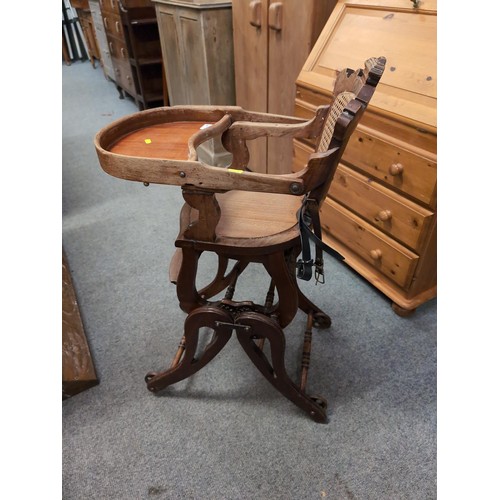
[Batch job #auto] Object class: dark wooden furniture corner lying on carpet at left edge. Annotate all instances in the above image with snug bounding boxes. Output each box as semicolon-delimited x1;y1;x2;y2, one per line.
62;251;99;399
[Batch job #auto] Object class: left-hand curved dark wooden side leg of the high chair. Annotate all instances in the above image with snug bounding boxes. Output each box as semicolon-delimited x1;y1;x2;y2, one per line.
146;306;233;392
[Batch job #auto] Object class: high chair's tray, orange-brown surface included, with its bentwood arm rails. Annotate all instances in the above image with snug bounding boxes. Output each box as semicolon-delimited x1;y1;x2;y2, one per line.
94;106;305;195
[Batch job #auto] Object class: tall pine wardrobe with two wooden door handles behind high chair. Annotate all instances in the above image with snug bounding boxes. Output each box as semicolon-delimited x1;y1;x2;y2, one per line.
233;0;336;173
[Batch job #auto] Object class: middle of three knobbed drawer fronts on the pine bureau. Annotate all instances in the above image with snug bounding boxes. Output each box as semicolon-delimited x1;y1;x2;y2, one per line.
329;164;434;252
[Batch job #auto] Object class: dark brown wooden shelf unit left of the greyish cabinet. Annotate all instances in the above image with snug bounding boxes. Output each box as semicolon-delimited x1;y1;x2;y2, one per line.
101;0;163;109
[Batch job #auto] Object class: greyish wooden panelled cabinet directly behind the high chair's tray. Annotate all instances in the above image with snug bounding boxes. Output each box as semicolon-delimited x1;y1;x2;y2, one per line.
154;0;235;165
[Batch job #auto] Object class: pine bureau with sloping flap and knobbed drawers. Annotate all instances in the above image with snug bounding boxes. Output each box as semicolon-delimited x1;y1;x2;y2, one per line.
294;0;437;315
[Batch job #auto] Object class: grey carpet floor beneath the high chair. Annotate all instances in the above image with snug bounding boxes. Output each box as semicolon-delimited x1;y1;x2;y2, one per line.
62;62;436;500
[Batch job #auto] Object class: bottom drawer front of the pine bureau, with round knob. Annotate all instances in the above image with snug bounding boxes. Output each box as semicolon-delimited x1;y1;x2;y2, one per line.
321;198;418;290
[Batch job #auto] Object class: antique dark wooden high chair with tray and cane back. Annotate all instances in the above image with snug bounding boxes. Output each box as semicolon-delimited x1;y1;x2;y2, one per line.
95;57;385;422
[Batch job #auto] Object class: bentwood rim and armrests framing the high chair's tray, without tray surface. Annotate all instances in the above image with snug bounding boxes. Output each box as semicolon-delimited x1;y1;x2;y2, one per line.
94;102;330;195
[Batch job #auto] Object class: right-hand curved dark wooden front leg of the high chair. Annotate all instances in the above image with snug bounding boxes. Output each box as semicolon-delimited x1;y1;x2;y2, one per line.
235;312;327;422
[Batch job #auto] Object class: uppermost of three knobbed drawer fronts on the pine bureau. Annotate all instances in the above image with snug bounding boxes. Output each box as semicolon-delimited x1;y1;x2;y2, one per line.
342;129;437;207
